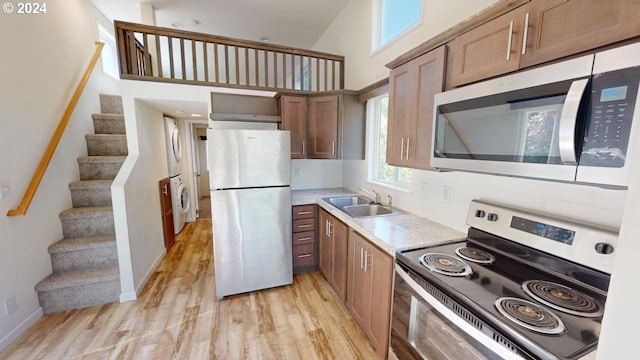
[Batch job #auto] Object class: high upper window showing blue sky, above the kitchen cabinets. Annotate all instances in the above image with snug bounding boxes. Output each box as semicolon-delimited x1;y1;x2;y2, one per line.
371;0;422;51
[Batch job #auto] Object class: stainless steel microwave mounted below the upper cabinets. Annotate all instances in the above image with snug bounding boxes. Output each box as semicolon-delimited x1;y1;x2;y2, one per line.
431;43;640;189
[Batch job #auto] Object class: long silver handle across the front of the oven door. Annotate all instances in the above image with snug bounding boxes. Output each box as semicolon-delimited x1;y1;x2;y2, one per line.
395;264;524;360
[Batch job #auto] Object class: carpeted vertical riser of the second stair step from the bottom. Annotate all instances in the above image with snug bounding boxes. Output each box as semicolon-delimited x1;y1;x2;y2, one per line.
51;245;118;272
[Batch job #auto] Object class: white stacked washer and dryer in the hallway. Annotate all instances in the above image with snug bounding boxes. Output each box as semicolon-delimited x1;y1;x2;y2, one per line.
164;117;190;234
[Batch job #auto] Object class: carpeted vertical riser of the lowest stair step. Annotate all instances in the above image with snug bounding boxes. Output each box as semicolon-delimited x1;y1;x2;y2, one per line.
38;280;120;314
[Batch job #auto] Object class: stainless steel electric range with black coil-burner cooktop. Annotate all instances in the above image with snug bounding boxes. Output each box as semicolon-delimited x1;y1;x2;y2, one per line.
391;201;617;360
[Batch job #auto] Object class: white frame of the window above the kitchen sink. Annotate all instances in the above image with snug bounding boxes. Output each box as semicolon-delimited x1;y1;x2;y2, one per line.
366;93;413;192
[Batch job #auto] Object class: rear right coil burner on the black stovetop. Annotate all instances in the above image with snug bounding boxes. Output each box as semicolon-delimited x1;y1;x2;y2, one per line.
522;280;603;317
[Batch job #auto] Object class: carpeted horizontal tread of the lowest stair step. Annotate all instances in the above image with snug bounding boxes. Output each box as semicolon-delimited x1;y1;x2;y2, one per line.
35;266;120;291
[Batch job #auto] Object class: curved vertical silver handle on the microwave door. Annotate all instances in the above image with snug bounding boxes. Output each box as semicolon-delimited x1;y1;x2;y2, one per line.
558;79;589;163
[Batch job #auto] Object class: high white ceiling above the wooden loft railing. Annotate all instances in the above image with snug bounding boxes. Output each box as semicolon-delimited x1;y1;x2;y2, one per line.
90;0;349;49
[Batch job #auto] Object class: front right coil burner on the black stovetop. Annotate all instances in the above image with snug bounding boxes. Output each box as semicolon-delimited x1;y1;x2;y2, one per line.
495;297;565;335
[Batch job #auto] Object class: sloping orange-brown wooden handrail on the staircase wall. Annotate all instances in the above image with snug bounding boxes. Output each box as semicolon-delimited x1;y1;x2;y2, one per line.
7;41;104;216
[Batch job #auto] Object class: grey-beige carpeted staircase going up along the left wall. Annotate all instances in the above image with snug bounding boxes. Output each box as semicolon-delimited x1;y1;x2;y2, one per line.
36;95;127;314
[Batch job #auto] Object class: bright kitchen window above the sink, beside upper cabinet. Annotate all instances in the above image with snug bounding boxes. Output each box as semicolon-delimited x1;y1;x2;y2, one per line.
367;95;411;188
